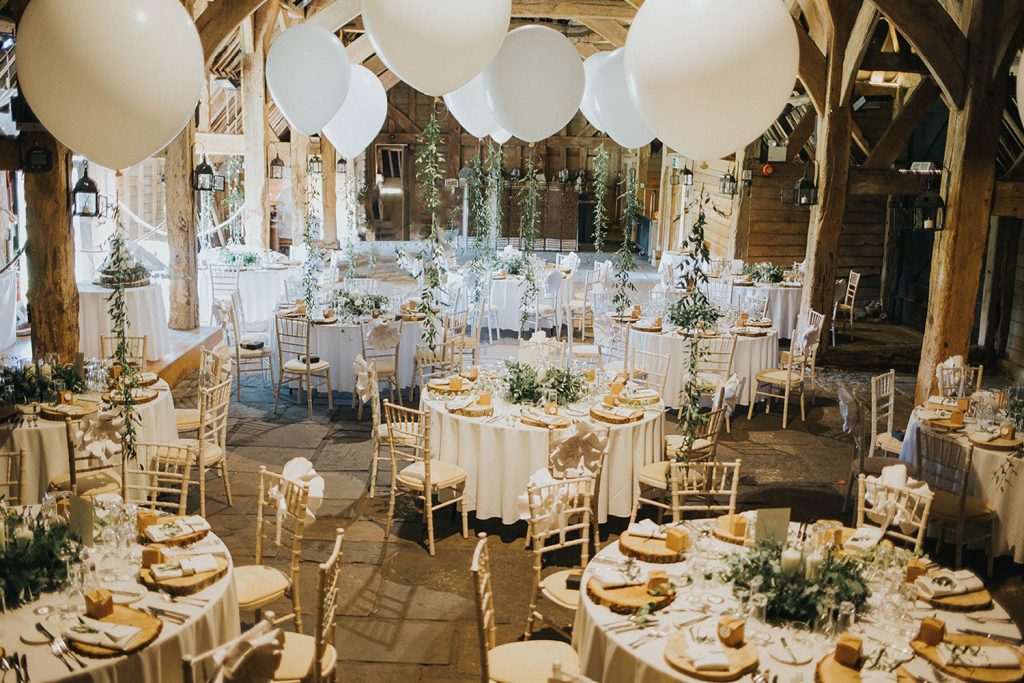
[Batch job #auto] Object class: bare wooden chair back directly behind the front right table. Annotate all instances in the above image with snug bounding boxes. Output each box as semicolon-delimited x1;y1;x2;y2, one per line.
669;460;741;519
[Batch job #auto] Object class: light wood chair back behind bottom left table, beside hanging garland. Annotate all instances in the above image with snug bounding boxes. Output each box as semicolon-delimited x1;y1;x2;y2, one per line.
121;443;194;515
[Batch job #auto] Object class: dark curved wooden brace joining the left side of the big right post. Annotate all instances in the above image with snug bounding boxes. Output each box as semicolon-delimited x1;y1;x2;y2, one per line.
869;0;967;110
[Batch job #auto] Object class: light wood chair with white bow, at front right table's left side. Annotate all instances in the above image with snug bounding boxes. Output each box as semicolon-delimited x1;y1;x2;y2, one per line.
523;476;596;640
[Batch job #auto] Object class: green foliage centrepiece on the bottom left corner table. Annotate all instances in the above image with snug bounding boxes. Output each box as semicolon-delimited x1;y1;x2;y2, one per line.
0;504;78;609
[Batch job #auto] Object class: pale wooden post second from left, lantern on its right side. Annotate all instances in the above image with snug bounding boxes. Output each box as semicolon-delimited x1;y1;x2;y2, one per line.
164;118;197;330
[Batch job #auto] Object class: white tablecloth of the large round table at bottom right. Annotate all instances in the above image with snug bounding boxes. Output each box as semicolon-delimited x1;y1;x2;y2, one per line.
572;521;1020;683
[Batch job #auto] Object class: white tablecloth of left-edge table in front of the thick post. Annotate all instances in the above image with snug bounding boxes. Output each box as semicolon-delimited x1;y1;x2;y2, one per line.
0;381;178;504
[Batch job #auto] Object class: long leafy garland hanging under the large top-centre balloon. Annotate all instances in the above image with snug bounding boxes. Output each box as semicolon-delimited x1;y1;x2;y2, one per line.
416;110;444;351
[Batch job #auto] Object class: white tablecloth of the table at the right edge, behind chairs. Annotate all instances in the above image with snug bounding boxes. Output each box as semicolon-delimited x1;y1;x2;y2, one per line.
899;414;1024;562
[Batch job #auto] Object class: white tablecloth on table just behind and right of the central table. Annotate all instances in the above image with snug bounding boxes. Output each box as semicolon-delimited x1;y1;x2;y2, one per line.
630;328;778;408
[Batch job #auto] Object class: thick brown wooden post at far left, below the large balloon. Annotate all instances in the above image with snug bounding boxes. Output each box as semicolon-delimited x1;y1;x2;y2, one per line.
23;133;79;361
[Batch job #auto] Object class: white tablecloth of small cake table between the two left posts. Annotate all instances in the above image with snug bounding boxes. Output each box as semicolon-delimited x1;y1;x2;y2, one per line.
78;283;171;360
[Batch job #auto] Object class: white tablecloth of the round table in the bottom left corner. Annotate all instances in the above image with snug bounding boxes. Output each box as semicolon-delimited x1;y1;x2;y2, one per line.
0;532;241;683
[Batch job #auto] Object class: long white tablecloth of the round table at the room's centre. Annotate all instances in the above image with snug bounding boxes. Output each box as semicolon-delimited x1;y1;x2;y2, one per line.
421;392;665;524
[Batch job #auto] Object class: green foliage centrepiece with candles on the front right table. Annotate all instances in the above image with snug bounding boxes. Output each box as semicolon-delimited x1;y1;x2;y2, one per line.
726;541;871;623
